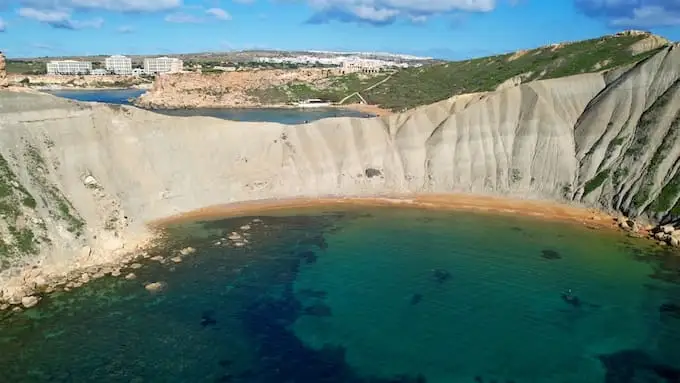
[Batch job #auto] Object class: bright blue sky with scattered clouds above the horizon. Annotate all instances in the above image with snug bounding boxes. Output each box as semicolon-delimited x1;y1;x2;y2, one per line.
0;0;680;59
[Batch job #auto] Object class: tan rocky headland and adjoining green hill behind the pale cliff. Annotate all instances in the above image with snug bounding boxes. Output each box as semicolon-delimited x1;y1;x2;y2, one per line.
139;31;669;111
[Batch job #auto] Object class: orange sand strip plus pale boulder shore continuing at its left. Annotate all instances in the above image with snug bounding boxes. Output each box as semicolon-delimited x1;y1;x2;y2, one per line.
0;194;660;313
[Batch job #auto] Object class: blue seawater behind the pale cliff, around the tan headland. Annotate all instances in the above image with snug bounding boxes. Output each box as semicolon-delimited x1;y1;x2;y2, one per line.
47;89;373;124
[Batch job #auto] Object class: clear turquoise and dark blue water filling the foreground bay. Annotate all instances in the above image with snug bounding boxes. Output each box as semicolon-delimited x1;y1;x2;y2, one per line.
0;208;680;383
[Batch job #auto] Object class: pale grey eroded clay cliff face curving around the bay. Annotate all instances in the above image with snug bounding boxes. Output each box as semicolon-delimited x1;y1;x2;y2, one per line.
0;46;680;296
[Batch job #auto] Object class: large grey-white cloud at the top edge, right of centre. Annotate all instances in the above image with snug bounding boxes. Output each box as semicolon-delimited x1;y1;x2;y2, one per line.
308;0;496;25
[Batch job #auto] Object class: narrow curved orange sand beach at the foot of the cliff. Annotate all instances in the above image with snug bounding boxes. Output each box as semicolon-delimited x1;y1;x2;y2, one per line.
149;194;617;229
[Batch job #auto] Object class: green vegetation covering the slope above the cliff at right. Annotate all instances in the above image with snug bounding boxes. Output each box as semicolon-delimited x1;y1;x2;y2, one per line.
362;35;668;110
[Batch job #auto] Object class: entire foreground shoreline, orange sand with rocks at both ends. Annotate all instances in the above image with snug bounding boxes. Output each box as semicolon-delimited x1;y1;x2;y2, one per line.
0;195;680;313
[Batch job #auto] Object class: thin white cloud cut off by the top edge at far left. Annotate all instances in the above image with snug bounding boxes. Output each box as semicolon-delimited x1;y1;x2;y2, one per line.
21;0;182;12
